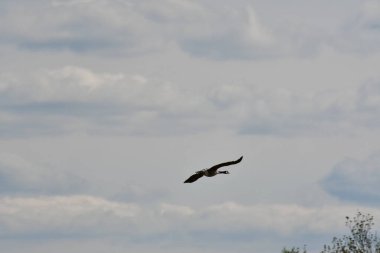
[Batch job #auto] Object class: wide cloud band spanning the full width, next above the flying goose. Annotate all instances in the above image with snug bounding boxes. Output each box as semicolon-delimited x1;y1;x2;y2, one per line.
0;66;380;137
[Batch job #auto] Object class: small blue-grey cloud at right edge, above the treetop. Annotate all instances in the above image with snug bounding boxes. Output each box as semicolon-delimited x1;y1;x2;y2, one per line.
321;154;380;205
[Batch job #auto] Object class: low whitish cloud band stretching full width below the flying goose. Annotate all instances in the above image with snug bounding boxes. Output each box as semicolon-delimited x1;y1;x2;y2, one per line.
0;195;380;241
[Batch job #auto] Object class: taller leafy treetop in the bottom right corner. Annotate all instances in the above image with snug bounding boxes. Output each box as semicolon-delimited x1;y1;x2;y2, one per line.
321;212;380;253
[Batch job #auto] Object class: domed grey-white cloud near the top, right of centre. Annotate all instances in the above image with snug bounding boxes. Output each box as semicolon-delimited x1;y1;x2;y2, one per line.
179;3;282;60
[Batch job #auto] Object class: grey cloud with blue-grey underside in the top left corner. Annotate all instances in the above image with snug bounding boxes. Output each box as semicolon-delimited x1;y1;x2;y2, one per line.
0;0;166;55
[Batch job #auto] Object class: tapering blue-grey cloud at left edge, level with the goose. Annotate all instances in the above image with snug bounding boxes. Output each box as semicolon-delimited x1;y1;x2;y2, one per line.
0;153;169;203
